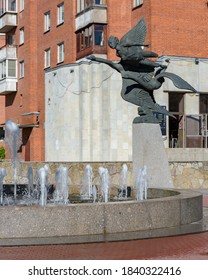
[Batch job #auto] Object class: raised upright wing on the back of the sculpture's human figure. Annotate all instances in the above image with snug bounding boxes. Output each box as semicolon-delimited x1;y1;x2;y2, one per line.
120;18;147;47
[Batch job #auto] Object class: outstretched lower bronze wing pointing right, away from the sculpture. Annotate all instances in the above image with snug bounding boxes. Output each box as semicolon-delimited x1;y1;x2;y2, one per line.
155;72;197;92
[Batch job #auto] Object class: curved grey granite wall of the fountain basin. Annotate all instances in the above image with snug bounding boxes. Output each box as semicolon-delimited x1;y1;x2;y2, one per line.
0;189;203;238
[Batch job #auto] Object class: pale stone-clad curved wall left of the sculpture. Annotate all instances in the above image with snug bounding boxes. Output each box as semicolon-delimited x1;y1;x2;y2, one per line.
45;61;137;161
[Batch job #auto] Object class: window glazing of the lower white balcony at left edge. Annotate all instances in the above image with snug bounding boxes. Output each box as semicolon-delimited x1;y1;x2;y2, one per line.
0;59;17;80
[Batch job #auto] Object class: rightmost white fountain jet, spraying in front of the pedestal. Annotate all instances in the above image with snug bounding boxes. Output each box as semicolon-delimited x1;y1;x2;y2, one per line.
136;165;148;200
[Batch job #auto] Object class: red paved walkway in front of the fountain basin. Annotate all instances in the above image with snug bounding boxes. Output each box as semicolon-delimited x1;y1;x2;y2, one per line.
0;190;208;260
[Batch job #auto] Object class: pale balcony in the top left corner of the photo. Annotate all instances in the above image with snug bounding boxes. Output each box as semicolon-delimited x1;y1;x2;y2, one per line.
0;0;17;33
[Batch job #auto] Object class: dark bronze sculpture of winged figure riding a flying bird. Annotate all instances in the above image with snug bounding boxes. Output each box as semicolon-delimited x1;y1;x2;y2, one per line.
87;19;196;123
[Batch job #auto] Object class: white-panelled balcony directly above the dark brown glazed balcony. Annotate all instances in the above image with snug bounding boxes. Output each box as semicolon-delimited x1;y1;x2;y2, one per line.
75;0;107;31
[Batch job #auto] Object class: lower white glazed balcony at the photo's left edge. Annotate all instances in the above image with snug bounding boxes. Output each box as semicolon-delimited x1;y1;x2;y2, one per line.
0;46;17;95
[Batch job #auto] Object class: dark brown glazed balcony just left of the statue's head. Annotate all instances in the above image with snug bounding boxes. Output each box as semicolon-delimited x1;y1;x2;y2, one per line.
77;24;106;57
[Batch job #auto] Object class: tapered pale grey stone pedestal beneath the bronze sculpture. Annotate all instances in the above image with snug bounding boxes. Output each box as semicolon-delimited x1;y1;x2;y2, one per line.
132;123;173;189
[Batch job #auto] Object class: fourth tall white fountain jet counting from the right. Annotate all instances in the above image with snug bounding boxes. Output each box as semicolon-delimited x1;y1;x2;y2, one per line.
81;164;93;199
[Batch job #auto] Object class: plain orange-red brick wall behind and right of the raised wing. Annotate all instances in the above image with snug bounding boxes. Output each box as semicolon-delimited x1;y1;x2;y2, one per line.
132;0;208;57
